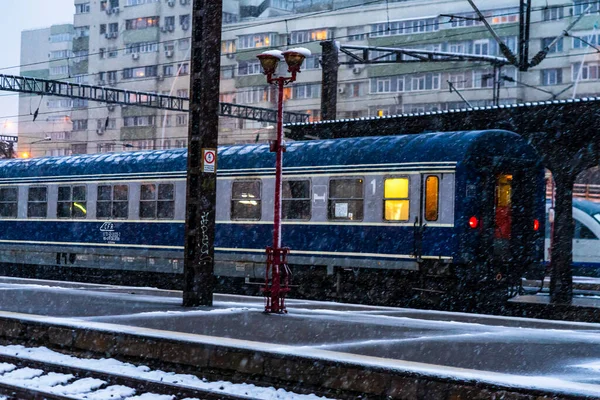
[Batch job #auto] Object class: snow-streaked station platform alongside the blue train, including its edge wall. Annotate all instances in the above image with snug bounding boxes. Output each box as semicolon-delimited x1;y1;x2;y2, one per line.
0;279;600;399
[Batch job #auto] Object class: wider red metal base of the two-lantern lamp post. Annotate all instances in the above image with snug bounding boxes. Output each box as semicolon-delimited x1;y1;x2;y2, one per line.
261;246;291;314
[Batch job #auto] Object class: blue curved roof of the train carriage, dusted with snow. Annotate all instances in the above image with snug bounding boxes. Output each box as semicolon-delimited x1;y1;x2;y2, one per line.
0;131;529;178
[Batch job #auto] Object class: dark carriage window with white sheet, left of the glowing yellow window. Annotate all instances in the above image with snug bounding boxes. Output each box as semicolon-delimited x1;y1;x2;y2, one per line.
328;179;364;221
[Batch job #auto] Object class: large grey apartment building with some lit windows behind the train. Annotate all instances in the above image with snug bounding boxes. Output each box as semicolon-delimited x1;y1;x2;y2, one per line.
22;0;600;155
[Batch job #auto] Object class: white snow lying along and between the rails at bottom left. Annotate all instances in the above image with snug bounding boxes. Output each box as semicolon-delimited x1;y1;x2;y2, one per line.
0;345;326;400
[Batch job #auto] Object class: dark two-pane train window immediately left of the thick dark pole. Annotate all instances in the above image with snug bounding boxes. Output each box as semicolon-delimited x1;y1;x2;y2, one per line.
140;183;175;219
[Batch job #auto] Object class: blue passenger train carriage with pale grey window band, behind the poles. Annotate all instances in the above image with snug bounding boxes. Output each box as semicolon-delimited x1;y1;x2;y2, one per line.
0;131;544;301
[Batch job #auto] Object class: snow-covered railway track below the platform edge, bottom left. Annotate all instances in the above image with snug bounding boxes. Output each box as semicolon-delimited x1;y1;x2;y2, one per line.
0;355;252;400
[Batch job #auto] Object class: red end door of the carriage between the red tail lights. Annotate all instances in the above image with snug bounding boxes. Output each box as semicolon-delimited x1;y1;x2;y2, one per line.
494;174;513;260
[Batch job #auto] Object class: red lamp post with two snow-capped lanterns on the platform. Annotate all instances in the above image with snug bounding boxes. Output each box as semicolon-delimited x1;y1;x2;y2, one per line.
257;48;310;314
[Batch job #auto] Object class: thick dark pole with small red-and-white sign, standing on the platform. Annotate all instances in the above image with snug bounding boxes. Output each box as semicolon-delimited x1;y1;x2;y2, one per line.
183;0;223;307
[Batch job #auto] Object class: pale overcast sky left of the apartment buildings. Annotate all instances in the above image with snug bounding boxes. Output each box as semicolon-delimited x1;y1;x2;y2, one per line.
0;0;75;134
